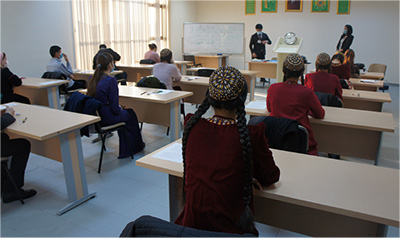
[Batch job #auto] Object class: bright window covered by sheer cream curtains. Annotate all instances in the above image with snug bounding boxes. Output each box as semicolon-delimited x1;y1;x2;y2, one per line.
72;0;169;69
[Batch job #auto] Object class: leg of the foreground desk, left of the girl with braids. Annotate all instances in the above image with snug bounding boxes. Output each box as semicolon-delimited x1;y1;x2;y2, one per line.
168;175;184;222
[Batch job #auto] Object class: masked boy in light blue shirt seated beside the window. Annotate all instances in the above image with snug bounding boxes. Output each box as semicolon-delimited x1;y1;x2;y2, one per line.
46;45;86;90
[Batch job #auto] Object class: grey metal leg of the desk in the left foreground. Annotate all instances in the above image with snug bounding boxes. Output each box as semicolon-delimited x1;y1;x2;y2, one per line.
57;129;96;216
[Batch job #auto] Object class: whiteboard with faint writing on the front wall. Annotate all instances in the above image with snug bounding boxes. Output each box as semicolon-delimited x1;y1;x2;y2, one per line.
183;22;244;55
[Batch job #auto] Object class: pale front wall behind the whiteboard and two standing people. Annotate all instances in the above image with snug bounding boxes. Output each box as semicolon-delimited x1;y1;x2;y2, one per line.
171;0;399;84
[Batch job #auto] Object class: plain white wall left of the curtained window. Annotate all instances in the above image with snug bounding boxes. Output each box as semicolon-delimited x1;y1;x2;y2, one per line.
0;0;75;77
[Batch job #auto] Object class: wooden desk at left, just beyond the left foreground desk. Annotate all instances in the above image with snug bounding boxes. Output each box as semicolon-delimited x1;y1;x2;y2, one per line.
14;78;68;109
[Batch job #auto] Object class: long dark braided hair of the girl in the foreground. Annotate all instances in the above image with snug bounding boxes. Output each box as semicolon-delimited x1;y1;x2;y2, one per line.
182;71;256;233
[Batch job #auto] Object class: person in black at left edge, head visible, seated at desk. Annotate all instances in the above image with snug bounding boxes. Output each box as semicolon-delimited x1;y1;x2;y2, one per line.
0;52;31;104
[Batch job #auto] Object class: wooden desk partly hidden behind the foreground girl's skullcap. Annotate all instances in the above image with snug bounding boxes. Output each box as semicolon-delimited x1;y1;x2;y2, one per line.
173;70;258;104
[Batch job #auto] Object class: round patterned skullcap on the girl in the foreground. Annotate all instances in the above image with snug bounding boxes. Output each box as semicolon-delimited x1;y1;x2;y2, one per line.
208;66;246;101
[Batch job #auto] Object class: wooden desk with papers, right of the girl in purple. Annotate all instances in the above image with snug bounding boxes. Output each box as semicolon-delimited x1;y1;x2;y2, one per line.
119;85;193;141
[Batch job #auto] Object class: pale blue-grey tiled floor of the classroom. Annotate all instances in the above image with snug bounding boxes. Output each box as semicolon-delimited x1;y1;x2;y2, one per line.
1;81;399;237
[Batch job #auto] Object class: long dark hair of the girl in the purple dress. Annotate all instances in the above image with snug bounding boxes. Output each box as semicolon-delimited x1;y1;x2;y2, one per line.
86;52;114;97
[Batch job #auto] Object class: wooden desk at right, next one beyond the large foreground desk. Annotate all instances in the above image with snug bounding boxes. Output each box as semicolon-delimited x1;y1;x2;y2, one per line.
246;101;394;165
